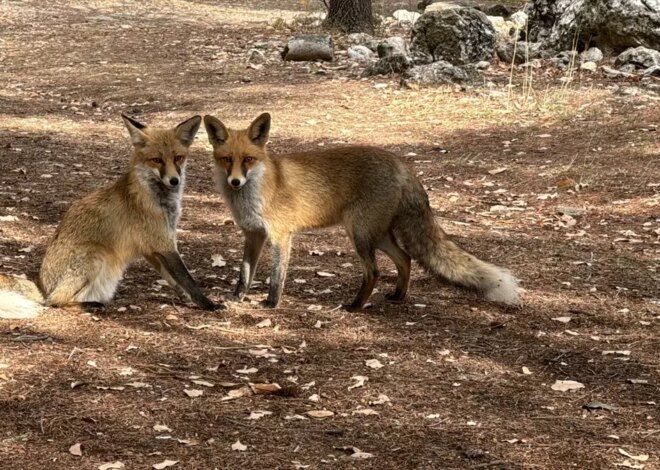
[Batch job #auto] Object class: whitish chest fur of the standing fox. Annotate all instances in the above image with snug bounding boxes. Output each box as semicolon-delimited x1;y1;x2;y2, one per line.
215;168;267;232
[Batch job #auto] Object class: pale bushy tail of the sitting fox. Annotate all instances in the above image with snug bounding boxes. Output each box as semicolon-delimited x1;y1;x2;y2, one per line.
0;274;44;320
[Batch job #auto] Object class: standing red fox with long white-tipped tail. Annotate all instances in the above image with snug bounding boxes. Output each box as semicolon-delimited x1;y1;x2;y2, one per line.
204;113;518;311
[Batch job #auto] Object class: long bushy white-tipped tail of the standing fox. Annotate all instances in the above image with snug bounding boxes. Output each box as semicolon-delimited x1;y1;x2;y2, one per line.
394;180;519;305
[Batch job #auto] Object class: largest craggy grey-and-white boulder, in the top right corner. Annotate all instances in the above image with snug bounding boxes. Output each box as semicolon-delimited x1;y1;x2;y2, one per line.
529;0;660;52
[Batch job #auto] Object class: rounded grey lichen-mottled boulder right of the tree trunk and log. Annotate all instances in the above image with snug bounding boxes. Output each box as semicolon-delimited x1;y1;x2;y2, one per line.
411;8;496;65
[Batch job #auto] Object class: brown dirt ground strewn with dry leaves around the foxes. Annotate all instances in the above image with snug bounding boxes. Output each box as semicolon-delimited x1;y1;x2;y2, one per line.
0;0;660;469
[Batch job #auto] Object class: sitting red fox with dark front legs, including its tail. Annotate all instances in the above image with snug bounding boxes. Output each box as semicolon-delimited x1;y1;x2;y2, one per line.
0;115;222;318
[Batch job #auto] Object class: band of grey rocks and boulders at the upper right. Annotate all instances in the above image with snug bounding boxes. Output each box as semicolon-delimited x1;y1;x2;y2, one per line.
266;0;660;92
